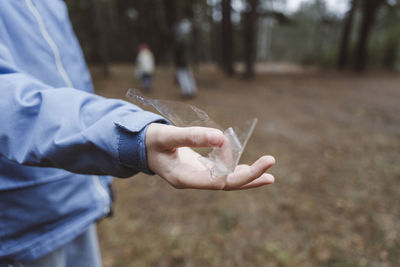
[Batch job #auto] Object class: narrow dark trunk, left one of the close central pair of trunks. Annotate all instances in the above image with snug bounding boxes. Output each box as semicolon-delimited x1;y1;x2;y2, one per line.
221;0;234;76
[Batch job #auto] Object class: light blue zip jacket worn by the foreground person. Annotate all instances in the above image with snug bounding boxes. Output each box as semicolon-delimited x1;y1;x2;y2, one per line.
0;0;165;262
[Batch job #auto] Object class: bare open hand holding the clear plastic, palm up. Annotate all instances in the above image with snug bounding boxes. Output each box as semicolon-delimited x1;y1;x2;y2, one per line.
146;123;275;190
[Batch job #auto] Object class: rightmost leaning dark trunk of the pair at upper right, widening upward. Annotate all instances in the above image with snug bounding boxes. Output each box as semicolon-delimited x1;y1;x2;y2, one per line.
354;0;383;72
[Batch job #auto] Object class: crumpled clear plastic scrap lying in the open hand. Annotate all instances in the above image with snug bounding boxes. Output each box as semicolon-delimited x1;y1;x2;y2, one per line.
126;89;258;178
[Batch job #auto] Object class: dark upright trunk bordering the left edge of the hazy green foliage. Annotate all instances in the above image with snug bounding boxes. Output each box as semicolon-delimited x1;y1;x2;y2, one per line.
243;0;259;79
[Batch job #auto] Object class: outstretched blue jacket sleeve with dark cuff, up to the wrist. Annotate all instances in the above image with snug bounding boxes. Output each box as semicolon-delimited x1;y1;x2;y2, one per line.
0;43;167;177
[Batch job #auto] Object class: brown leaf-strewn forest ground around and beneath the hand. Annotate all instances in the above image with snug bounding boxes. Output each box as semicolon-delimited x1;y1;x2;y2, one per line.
92;65;400;267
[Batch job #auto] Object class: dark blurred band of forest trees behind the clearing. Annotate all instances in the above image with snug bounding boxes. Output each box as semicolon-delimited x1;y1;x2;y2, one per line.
66;0;400;78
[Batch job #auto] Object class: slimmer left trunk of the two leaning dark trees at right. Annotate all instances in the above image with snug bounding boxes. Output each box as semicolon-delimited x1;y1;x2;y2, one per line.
338;0;357;70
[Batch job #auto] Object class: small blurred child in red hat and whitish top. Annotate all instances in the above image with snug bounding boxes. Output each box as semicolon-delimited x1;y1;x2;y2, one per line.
136;44;154;91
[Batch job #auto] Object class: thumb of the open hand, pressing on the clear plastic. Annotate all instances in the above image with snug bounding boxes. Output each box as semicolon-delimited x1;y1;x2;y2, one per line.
158;126;225;148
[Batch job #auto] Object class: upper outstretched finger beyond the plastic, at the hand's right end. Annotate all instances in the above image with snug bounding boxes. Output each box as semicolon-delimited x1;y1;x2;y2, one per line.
225;156;275;190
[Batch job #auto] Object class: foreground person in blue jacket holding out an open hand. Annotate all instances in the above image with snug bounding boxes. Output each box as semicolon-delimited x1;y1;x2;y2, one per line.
0;0;274;267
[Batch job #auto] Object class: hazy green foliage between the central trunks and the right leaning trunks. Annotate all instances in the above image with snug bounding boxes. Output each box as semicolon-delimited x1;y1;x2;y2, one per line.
272;0;341;66
